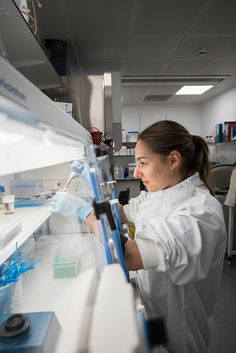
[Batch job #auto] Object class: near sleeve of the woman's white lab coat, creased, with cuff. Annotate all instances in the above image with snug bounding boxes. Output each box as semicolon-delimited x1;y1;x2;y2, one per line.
136;198;225;285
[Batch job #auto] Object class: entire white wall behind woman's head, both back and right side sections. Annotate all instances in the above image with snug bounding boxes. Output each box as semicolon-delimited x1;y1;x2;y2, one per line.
122;87;236;138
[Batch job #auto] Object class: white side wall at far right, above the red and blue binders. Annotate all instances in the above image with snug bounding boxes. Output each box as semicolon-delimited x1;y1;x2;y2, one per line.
200;87;236;136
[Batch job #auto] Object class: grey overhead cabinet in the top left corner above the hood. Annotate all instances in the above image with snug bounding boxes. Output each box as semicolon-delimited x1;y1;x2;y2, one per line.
0;0;63;89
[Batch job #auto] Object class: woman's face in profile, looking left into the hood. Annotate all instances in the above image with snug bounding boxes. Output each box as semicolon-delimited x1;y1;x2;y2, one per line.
134;140;181;192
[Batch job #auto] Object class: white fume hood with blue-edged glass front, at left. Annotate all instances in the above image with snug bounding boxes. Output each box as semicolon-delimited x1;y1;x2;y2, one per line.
0;58;164;353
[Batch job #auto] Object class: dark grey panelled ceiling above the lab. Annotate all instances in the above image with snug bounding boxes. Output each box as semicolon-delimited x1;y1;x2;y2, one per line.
16;0;236;104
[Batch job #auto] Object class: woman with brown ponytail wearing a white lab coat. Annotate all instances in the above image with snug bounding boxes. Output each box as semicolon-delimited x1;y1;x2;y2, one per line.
52;120;226;353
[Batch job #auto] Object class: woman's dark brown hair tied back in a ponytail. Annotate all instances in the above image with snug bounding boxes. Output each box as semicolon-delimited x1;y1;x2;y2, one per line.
138;120;213;194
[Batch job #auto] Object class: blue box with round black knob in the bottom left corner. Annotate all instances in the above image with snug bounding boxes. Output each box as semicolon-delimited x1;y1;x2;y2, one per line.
0;312;61;353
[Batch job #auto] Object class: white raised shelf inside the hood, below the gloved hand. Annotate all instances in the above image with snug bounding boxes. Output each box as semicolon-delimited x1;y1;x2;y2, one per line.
0;206;51;264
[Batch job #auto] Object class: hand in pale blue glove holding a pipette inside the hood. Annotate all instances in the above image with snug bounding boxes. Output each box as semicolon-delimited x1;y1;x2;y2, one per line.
51;191;93;223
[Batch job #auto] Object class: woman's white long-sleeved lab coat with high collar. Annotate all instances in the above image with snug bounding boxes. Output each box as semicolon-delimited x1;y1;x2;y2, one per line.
124;173;226;353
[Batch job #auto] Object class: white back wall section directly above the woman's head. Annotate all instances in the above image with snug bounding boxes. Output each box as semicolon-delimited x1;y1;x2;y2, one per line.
122;104;201;135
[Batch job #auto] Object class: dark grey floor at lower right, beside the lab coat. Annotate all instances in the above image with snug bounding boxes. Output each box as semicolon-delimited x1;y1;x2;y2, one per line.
209;256;236;353
